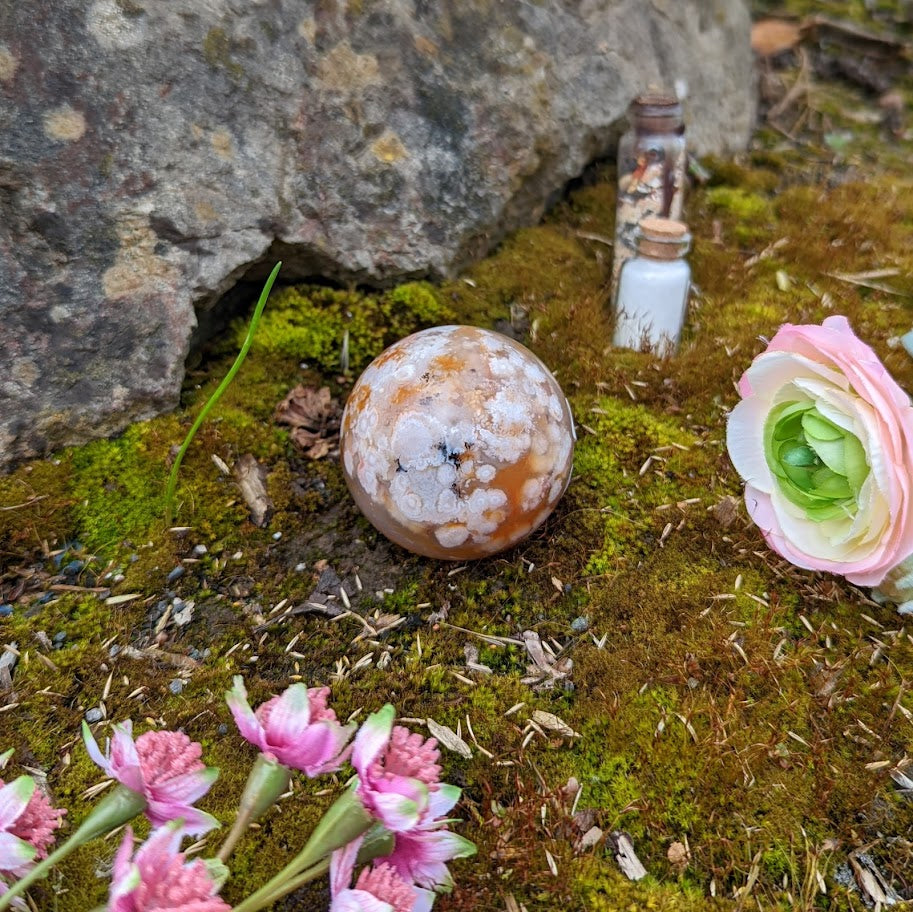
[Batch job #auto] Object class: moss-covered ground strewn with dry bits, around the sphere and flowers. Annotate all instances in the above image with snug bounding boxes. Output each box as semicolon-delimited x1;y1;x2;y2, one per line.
0;4;913;912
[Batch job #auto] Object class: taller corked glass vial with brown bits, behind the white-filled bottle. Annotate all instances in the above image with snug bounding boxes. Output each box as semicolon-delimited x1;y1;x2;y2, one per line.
612;94;687;290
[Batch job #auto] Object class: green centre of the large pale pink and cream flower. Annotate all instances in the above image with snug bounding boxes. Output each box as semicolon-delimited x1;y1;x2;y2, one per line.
764;402;869;522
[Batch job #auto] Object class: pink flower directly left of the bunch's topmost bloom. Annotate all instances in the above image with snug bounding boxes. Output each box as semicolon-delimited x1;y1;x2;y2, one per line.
82;720;219;836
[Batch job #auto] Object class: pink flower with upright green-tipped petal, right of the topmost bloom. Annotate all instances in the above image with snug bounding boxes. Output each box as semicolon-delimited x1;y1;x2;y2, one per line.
352;703;441;833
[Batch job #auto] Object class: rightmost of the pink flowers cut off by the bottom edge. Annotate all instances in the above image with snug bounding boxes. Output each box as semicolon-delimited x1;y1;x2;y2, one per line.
330;839;434;912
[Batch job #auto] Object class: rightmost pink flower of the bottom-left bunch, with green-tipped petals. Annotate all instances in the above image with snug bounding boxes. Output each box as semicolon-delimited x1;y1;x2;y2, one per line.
384;784;476;892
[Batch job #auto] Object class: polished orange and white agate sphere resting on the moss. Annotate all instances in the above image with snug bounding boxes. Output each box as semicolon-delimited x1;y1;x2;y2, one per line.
341;326;574;560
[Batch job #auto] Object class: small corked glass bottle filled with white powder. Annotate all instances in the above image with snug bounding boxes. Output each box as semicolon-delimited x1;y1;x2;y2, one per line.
612;218;691;356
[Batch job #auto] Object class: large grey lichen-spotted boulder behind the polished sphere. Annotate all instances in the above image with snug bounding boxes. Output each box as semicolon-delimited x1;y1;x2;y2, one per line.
0;0;753;465
